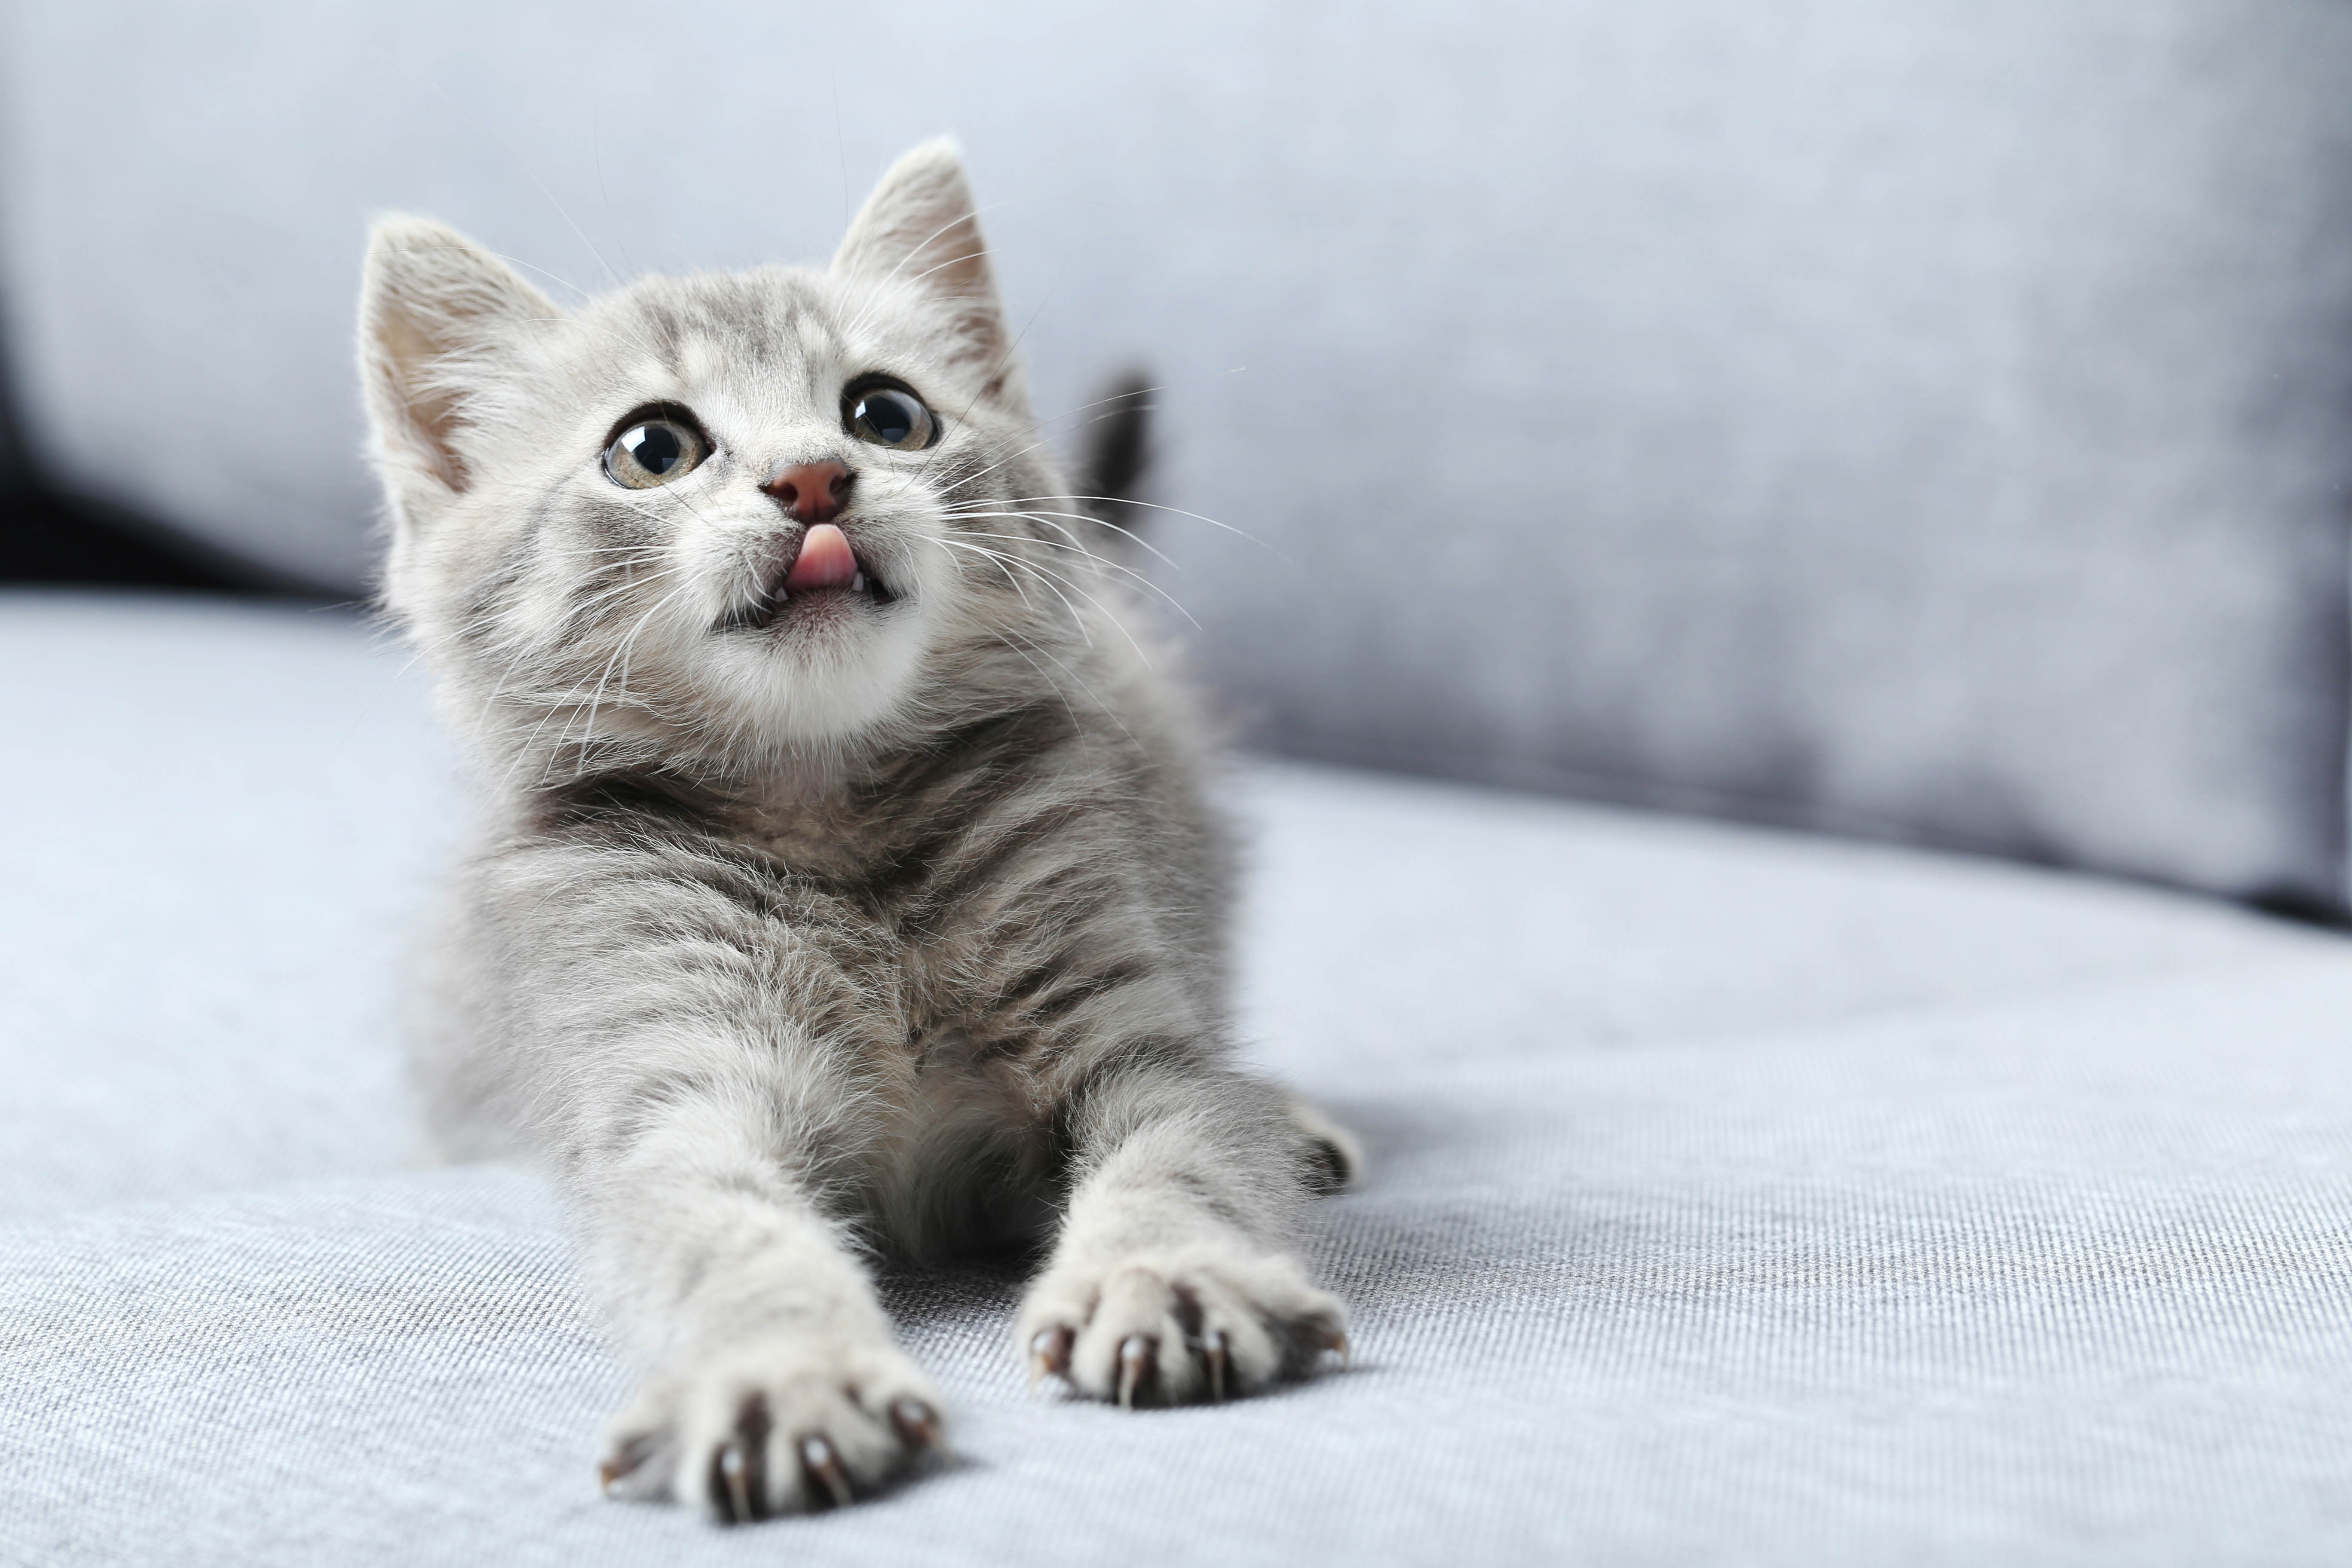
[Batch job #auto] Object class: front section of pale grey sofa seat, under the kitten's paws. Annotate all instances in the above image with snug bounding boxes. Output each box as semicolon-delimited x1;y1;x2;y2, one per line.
14;945;2352;1568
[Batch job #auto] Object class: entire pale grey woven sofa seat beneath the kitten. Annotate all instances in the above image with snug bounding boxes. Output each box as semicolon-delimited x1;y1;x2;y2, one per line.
0;592;2352;1568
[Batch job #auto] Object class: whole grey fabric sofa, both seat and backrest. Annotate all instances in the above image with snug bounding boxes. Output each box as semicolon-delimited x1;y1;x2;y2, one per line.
0;0;2352;1568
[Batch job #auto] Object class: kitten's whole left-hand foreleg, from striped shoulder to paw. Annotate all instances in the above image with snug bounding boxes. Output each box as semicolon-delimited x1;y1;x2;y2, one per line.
468;846;941;1519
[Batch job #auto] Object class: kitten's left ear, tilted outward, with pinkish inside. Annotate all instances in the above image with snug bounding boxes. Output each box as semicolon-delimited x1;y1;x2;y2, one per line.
360;216;562;517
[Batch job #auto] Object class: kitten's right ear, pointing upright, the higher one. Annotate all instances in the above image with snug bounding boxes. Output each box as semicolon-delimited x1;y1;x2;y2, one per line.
833;136;1007;390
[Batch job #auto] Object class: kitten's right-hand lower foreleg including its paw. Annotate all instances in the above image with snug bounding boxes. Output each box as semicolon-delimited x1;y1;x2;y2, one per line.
1014;1065;1352;1406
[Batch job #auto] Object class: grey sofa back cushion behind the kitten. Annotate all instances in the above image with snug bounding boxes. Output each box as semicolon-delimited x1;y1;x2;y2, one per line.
0;0;2352;900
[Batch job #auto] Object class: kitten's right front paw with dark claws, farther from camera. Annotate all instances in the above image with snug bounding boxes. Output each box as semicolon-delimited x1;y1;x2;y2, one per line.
1014;1246;1348;1406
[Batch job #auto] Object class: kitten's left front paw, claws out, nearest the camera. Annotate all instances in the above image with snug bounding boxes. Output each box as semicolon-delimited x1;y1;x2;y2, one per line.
602;1335;946;1523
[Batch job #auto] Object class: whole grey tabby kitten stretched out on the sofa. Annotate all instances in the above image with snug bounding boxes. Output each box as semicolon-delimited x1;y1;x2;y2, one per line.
360;141;1355;1521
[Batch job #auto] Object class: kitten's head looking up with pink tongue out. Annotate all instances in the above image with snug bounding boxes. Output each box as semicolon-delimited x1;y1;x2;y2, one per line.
360;141;1093;771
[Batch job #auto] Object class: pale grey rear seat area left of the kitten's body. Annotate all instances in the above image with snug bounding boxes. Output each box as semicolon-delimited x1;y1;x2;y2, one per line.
0;590;461;1216
